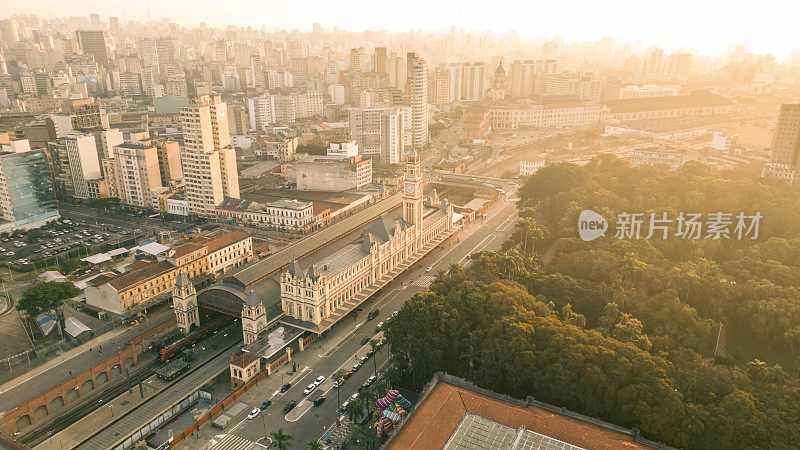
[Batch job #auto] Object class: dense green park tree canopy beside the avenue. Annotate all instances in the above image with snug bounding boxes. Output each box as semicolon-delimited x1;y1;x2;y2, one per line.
387;157;800;448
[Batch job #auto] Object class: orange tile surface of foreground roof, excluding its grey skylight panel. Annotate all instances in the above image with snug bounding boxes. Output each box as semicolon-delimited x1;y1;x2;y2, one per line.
387;374;656;449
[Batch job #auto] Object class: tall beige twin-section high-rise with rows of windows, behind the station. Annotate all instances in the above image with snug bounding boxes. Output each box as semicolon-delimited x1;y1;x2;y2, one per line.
181;96;239;217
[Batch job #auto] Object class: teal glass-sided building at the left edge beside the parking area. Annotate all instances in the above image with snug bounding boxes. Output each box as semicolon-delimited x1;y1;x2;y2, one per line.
0;140;59;231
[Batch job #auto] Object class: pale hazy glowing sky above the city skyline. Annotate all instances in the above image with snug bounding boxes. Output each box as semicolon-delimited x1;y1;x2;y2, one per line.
0;0;800;59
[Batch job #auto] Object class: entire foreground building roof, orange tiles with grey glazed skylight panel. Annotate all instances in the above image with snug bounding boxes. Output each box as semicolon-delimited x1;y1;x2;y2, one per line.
387;373;669;449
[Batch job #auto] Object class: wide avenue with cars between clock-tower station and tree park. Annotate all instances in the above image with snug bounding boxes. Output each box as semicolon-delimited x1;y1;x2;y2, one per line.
189;192;516;450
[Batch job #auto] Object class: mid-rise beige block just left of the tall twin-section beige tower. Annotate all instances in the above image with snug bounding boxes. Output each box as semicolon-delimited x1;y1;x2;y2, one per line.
114;143;161;208
